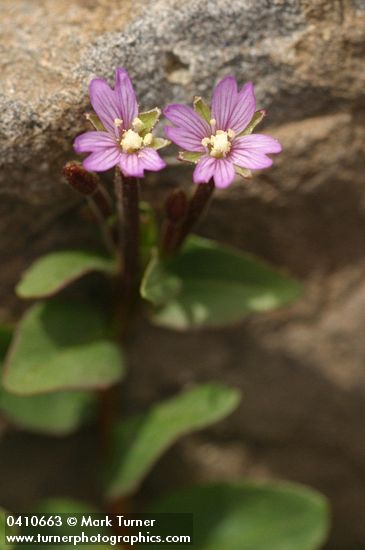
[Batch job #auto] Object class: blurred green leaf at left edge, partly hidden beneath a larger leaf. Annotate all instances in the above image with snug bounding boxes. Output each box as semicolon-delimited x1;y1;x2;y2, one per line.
0;326;95;435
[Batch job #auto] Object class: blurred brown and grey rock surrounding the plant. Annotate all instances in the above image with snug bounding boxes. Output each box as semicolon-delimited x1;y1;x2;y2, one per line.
0;0;365;550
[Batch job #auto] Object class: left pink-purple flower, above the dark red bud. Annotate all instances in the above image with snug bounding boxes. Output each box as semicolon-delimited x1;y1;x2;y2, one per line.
74;67;167;177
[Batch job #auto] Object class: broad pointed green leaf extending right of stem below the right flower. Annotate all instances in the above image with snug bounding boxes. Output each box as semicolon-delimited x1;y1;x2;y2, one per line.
141;236;301;330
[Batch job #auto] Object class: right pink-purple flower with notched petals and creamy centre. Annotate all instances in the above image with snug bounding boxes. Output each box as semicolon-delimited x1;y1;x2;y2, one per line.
164;76;281;187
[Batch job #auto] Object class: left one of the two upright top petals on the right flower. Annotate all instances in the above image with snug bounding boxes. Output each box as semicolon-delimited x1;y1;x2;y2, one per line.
212;76;238;131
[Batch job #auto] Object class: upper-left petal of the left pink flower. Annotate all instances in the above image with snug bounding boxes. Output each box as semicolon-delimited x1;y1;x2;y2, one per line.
89;78;122;135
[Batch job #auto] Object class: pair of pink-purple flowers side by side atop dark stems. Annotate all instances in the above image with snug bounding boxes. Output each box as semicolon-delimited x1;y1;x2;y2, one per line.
74;68;281;188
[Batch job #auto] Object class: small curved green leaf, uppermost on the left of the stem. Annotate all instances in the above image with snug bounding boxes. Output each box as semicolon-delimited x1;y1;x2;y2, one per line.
16;250;115;298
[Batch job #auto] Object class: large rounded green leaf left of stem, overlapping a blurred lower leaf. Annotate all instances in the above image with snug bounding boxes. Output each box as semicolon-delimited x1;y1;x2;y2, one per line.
3;301;124;395
